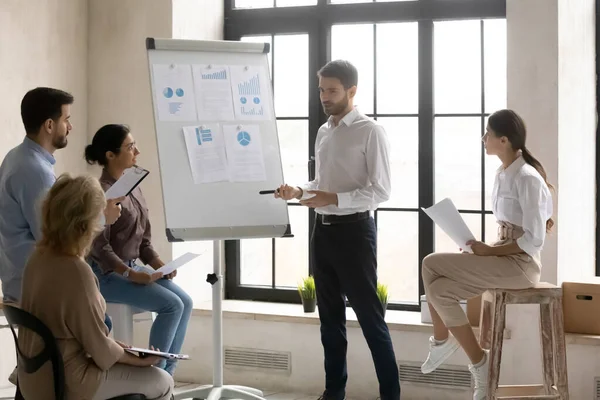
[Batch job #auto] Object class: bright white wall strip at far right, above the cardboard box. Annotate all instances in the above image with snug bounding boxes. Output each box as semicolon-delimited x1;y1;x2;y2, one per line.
558;0;596;282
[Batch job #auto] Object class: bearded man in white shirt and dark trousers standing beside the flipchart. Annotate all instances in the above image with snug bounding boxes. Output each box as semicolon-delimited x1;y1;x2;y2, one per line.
275;60;400;400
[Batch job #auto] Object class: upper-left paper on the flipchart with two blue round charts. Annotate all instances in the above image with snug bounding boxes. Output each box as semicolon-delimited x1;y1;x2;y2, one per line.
152;64;198;121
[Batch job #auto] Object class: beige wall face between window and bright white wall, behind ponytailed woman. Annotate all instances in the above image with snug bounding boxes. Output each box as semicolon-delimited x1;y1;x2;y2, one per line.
506;0;559;282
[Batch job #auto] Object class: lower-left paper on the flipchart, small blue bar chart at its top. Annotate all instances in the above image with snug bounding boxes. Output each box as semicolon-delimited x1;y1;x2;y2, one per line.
183;124;229;184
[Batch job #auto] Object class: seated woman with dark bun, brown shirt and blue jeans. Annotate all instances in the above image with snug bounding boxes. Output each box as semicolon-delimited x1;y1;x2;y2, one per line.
85;125;193;375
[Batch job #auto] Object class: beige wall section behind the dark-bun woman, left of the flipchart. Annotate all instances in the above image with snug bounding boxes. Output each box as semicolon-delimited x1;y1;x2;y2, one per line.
88;0;173;260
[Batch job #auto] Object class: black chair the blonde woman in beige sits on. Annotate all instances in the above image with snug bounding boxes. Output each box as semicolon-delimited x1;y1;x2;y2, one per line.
4;304;146;400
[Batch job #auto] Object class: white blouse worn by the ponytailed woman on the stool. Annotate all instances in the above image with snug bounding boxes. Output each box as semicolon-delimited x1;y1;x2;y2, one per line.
492;156;553;258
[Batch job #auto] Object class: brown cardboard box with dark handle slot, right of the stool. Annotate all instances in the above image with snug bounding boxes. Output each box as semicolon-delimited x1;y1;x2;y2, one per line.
562;282;600;335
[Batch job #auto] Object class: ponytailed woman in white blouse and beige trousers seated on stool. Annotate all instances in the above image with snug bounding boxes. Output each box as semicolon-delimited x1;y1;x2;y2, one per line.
421;110;554;400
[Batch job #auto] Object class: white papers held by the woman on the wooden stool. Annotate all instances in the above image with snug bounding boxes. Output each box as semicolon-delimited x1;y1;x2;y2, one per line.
422;198;475;253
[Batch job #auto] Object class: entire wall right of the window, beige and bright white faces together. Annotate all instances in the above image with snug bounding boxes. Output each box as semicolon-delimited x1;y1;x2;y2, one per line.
507;0;596;283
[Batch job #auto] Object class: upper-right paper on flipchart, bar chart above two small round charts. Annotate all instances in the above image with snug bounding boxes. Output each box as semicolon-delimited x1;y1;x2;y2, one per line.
229;65;271;120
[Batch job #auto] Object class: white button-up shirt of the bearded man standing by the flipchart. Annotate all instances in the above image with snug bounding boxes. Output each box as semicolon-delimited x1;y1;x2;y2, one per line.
302;108;391;215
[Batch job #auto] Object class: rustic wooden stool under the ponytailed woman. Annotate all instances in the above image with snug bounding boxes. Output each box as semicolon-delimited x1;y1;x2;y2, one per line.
479;282;569;400
